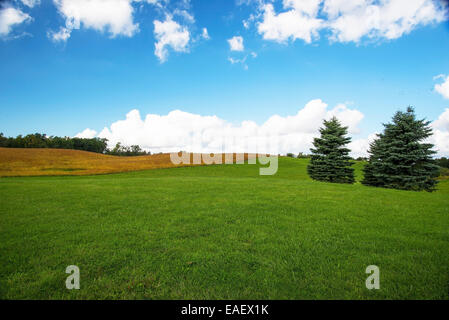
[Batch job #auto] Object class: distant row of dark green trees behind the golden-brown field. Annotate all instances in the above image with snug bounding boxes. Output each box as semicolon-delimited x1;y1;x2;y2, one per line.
0;133;151;156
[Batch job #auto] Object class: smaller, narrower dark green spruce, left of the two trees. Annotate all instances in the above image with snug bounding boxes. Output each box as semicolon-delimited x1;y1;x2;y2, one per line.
307;117;355;183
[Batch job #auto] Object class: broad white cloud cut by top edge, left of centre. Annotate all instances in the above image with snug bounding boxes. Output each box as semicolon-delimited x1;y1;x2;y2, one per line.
50;0;139;41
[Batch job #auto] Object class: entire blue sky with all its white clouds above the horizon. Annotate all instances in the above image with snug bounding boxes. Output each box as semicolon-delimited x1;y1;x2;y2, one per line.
0;0;449;156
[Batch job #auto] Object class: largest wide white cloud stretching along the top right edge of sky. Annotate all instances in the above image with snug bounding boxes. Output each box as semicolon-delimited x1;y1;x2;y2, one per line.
252;0;446;43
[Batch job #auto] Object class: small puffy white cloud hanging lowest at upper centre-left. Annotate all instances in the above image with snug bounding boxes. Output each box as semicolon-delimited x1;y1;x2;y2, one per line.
154;16;190;62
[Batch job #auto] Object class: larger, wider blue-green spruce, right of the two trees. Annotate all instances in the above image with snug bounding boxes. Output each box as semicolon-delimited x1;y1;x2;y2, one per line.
362;107;439;191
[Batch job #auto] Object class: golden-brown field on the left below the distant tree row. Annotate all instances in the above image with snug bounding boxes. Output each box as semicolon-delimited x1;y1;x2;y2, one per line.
0;148;254;177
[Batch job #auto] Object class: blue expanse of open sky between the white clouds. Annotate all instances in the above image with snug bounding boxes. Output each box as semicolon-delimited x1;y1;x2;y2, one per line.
0;0;449;152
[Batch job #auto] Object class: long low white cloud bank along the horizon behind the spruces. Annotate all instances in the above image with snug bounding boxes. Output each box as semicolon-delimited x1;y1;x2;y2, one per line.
75;99;363;154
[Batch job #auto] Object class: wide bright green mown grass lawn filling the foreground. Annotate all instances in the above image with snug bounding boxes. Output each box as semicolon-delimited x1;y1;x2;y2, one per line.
0;158;449;299
